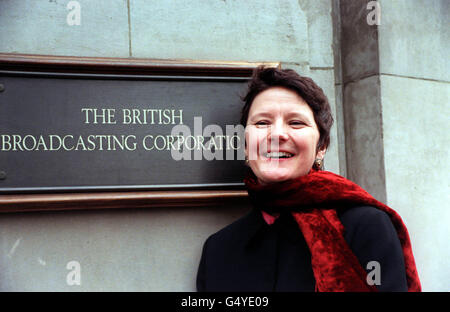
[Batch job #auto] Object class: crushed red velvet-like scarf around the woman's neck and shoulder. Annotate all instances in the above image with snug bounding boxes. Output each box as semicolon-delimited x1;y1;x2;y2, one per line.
244;170;421;292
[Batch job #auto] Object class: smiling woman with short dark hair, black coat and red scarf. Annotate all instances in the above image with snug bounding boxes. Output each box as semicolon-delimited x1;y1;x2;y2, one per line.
197;67;421;291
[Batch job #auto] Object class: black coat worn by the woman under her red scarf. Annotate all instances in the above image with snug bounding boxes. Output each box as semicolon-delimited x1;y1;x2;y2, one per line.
197;206;407;291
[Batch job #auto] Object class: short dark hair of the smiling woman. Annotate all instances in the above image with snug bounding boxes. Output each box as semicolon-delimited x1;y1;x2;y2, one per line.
241;66;333;150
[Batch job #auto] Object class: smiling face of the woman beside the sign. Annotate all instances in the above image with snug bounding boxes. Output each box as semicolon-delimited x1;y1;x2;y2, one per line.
245;87;325;184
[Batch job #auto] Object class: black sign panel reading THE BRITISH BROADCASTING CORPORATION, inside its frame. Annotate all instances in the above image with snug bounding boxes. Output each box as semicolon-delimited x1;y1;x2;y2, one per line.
0;56;264;194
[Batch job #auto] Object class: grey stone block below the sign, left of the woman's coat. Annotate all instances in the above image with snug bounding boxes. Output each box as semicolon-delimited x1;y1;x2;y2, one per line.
0;206;249;292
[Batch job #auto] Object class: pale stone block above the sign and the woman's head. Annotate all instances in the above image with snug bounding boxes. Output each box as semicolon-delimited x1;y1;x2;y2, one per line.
130;0;309;63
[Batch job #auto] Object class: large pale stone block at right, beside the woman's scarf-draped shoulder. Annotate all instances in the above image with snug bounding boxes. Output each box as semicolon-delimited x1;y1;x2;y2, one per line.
381;75;450;291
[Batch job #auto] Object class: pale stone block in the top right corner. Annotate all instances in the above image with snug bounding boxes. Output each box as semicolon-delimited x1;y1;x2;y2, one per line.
378;0;450;82
